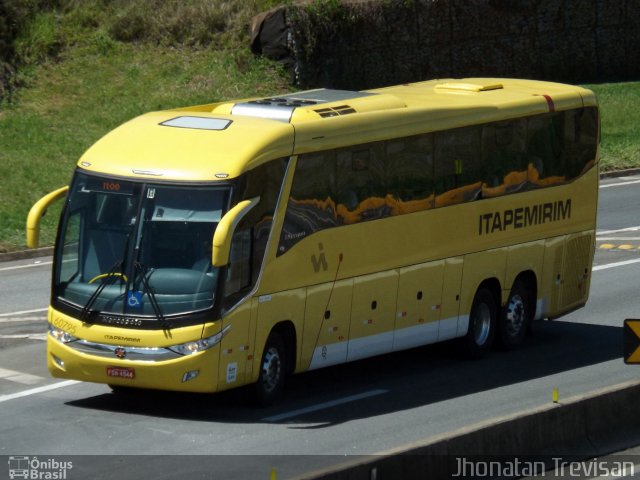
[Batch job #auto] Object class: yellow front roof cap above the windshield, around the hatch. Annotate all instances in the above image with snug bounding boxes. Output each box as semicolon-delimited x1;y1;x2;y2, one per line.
78;111;293;182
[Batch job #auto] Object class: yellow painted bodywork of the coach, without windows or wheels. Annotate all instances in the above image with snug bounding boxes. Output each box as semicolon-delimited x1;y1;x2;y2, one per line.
41;78;598;391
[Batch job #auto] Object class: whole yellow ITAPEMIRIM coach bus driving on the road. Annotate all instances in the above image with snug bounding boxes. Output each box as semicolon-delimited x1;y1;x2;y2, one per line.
27;78;599;403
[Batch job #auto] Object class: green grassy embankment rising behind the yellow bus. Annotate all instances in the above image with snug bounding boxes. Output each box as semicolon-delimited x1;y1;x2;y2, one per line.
0;0;640;252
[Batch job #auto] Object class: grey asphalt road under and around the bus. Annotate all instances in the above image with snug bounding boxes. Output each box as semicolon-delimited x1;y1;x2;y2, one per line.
0;176;640;479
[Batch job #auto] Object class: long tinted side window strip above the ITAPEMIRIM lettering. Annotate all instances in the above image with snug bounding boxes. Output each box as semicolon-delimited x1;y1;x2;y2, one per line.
278;108;598;254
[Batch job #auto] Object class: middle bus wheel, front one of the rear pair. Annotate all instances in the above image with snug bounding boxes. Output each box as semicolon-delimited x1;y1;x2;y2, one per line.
465;288;498;358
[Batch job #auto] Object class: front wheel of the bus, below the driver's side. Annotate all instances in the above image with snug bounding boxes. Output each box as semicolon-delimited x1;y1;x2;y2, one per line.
255;332;287;406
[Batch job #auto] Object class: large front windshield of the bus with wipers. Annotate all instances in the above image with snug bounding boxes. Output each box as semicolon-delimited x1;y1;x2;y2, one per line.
54;173;229;325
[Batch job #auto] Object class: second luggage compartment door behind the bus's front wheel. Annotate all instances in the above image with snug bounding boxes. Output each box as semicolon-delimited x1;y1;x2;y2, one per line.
347;270;399;361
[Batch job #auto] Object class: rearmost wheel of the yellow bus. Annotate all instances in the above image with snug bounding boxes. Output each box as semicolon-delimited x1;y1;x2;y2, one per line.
498;280;533;350
